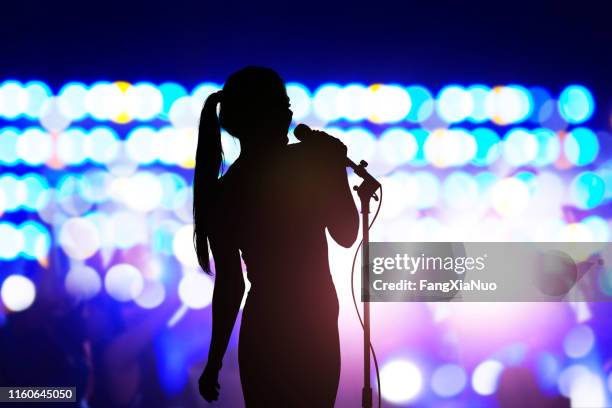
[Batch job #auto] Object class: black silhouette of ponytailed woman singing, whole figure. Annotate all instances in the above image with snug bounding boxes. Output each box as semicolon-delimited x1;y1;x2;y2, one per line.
193;67;359;408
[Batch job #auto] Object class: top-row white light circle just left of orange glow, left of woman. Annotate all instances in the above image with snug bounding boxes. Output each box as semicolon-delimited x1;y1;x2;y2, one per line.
85;82;125;121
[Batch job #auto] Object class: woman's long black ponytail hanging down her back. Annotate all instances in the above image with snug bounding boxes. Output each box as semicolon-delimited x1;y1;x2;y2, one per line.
193;91;223;274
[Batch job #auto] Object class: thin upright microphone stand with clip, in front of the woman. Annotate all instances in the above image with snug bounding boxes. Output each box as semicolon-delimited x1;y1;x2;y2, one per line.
346;158;380;408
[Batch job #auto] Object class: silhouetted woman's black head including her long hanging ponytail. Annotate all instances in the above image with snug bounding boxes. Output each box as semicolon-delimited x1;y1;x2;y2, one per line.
193;67;293;272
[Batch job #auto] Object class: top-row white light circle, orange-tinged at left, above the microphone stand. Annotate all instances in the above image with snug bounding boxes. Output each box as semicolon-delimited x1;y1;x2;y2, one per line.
368;84;412;123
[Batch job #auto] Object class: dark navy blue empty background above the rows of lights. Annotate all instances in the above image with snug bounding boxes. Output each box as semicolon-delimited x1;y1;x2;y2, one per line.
0;0;612;95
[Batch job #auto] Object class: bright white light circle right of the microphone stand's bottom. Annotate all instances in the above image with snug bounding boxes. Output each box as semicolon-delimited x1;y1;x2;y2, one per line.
380;360;423;404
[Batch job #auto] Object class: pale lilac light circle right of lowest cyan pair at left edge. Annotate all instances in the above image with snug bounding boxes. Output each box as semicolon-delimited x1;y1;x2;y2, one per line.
59;218;100;260
